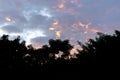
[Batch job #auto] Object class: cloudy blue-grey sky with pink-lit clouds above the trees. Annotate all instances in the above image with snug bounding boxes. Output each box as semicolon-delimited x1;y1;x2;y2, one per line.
0;0;120;47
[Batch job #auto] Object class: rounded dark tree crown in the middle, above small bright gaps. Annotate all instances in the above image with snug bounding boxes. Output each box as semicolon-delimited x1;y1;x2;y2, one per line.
49;39;73;57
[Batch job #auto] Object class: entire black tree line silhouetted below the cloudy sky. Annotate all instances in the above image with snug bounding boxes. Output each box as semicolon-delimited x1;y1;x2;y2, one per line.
0;30;120;71
